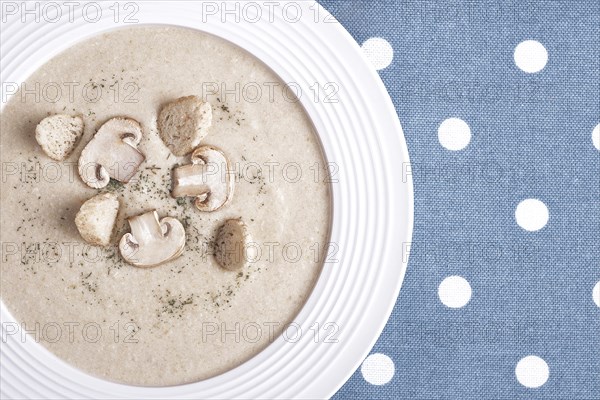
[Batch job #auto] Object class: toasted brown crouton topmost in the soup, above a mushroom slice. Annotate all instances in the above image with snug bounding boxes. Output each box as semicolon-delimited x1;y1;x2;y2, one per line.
157;96;212;156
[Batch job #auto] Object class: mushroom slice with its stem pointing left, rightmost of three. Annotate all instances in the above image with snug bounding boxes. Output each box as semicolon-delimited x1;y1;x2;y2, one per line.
171;146;234;212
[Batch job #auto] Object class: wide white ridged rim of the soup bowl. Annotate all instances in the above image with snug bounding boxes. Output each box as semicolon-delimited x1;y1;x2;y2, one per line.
0;1;413;399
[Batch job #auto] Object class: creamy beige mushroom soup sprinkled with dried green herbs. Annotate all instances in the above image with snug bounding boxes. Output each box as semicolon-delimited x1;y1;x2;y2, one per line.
0;26;331;385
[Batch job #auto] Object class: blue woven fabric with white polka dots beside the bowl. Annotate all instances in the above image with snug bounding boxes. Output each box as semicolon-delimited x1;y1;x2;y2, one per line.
321;0;600;400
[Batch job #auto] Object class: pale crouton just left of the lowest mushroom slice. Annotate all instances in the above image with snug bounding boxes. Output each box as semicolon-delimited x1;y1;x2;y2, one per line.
75;193;119;246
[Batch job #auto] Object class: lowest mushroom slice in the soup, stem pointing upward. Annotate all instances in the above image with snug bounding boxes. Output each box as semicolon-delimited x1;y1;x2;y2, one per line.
119;210;185;267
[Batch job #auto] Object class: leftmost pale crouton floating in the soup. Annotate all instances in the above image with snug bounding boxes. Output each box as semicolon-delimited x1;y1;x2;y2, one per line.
35;114;83;161
